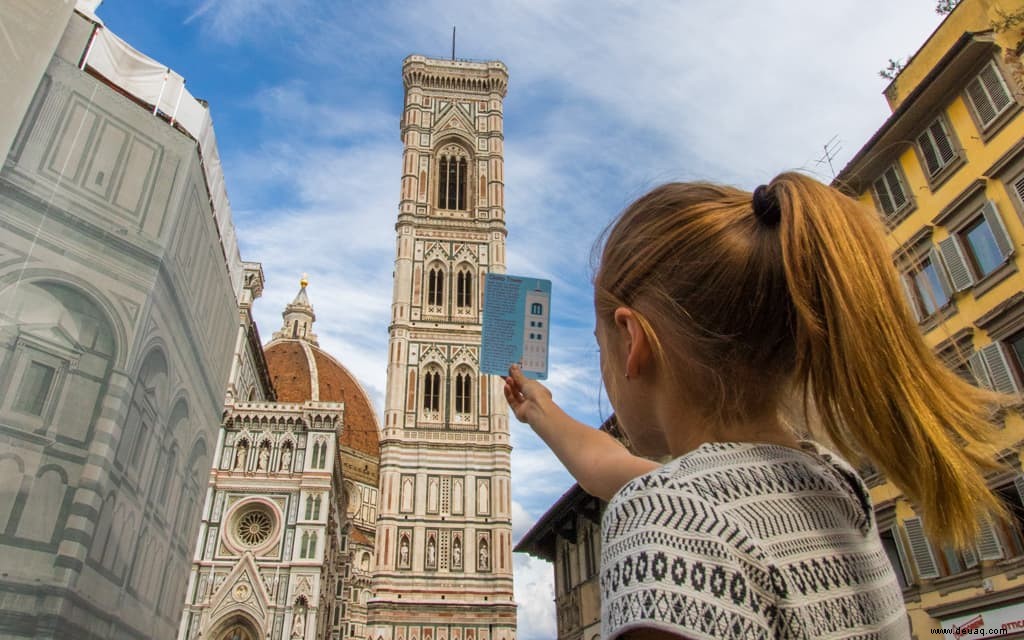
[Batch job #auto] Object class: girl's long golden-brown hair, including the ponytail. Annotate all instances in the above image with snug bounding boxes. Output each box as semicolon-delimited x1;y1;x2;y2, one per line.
594;173;1005;547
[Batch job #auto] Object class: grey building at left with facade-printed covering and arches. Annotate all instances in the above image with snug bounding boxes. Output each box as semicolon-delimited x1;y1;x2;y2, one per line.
0;14;239;638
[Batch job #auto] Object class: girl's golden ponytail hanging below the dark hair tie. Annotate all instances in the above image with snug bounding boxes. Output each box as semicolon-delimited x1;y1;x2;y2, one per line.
768;173;1005;547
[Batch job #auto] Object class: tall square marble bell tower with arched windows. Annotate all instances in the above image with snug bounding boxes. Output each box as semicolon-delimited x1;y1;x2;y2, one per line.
368;55;516;640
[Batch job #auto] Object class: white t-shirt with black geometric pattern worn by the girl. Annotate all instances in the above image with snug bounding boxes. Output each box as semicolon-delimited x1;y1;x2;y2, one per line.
601;442;909;640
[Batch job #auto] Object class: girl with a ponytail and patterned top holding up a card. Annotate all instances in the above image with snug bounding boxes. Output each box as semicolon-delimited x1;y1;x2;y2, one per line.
505;173;1002;640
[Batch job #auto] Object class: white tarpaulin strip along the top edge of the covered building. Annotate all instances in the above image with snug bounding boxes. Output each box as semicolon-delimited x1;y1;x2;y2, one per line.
78;0;243;299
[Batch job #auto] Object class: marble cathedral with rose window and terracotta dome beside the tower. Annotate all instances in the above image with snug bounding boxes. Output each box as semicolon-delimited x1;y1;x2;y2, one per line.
178;278;380;640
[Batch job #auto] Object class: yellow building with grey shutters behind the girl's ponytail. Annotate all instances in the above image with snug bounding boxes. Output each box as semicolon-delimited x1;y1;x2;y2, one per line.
836;0;1024;638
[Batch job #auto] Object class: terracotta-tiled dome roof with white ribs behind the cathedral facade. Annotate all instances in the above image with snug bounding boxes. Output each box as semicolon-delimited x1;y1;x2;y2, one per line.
263;339;380;458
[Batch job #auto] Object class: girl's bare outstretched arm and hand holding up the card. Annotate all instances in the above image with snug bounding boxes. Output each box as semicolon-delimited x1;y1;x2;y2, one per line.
505;365;658;501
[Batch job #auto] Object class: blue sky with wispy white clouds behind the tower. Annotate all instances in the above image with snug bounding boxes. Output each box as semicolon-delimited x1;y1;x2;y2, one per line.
97;0;940;640
